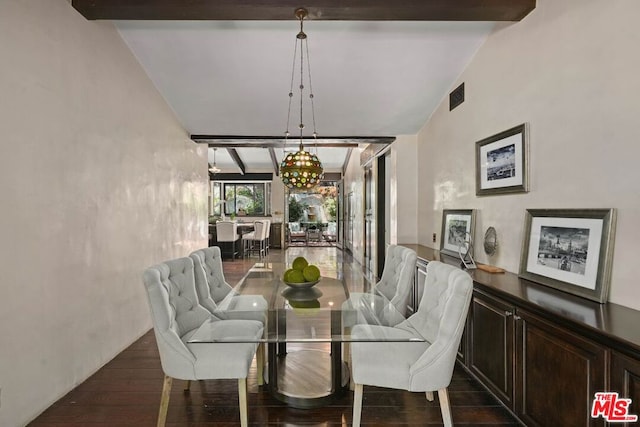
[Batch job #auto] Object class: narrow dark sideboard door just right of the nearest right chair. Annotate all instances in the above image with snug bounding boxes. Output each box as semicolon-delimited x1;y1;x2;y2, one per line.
467;292;515;408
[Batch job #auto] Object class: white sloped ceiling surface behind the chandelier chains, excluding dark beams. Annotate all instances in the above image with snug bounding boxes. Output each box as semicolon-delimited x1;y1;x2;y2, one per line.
116;20;495;172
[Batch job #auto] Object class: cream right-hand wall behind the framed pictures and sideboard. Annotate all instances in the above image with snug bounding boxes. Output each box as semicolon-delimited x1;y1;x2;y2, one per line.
418;0;640;309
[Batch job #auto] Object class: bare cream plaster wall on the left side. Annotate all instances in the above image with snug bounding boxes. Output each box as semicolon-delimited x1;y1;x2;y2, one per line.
0;0;208;426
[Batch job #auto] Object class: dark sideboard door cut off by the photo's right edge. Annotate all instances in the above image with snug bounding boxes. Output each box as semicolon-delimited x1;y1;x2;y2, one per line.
609;351;640;426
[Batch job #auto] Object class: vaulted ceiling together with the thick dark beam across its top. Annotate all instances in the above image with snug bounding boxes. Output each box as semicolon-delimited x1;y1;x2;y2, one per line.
72;0;535;172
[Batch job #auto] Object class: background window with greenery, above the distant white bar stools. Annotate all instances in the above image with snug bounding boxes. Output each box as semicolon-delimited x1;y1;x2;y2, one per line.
223;182;271;216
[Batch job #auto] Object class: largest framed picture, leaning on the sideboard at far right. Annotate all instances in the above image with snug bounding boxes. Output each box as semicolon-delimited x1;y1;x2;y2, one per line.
519;209;616;303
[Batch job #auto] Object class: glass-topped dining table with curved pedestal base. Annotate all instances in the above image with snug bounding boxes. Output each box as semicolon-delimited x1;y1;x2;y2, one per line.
189;262;424;409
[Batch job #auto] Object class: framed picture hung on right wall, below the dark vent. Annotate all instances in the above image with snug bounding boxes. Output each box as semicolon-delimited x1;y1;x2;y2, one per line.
476;123;529;196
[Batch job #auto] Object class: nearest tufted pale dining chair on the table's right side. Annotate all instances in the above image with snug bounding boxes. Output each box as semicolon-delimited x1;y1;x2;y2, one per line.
351;261;473;427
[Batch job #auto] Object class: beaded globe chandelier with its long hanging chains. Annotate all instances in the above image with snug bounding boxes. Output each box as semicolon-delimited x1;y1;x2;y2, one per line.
280;8;324;189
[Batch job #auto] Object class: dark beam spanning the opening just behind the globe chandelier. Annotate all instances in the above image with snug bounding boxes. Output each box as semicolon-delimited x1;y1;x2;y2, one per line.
191;135;396;148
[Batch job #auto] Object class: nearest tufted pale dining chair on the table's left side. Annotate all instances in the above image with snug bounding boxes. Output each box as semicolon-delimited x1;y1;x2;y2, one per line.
143;258;263;427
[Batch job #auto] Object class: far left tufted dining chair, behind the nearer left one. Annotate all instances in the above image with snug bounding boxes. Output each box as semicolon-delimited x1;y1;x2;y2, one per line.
189;246;268;322
